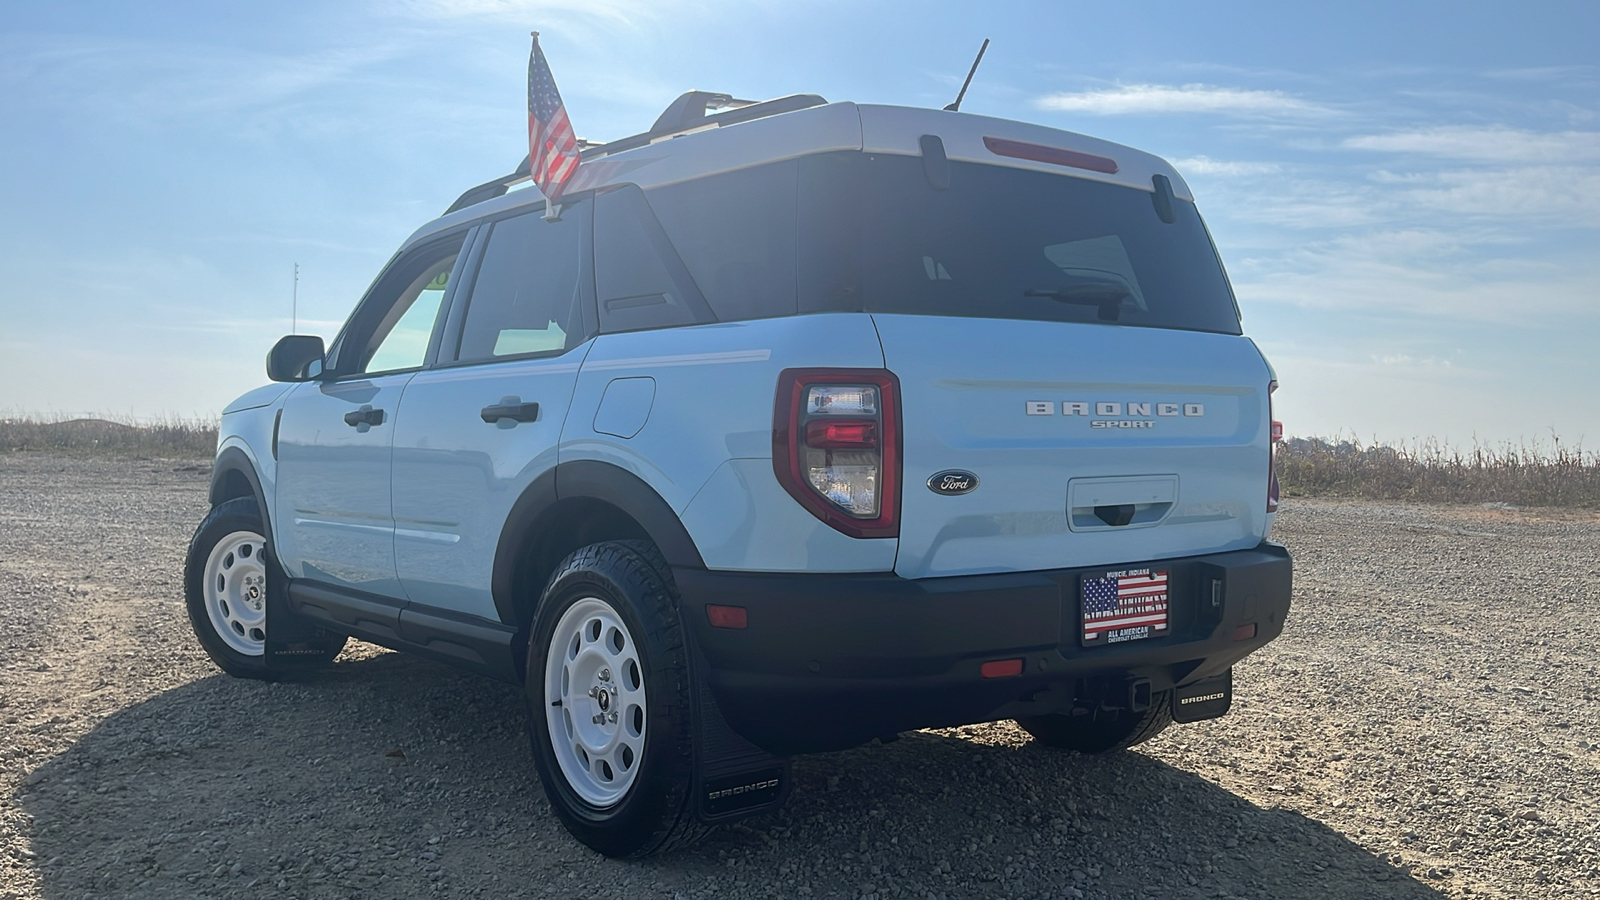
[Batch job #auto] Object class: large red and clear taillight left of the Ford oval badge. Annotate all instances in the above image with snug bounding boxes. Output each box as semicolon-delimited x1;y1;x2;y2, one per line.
773;368;901;538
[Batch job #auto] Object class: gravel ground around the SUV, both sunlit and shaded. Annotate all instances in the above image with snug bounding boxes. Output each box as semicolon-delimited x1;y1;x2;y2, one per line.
0;455;1600;900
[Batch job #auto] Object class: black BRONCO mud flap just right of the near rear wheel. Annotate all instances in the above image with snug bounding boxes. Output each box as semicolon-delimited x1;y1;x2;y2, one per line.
693;640;792;825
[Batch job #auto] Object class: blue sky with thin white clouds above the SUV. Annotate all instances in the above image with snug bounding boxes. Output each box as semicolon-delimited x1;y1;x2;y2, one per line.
0;0;1600;447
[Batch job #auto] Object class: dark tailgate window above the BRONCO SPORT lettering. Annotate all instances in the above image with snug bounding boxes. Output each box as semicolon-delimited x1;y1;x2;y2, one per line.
812;154;1240;335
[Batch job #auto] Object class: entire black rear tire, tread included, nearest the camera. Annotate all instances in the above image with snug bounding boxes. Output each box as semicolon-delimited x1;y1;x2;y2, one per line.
526;541;706;857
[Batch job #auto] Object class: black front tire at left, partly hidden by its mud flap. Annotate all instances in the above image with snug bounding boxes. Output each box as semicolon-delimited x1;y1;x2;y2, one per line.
184;496;346;681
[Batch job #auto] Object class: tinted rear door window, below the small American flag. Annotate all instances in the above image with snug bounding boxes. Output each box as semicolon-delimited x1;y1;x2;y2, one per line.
456;208;586;362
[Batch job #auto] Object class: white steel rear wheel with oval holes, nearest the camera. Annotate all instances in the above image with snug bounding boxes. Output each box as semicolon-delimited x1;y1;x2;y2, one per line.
544;597;648;809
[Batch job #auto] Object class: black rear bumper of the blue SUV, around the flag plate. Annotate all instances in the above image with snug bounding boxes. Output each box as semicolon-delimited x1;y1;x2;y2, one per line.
674;543;1293;753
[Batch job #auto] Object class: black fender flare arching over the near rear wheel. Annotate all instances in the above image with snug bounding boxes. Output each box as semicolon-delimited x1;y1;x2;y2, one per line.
490;460;706;628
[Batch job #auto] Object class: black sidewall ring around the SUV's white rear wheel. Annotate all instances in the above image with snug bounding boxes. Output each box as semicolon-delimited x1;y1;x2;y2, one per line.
525;544;693;855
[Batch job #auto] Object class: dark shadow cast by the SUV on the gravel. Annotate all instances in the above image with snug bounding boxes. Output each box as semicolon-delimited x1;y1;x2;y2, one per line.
13;643;1437;900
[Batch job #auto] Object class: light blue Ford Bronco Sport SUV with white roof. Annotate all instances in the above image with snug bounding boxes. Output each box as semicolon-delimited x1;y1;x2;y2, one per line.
186;93;1291;855
